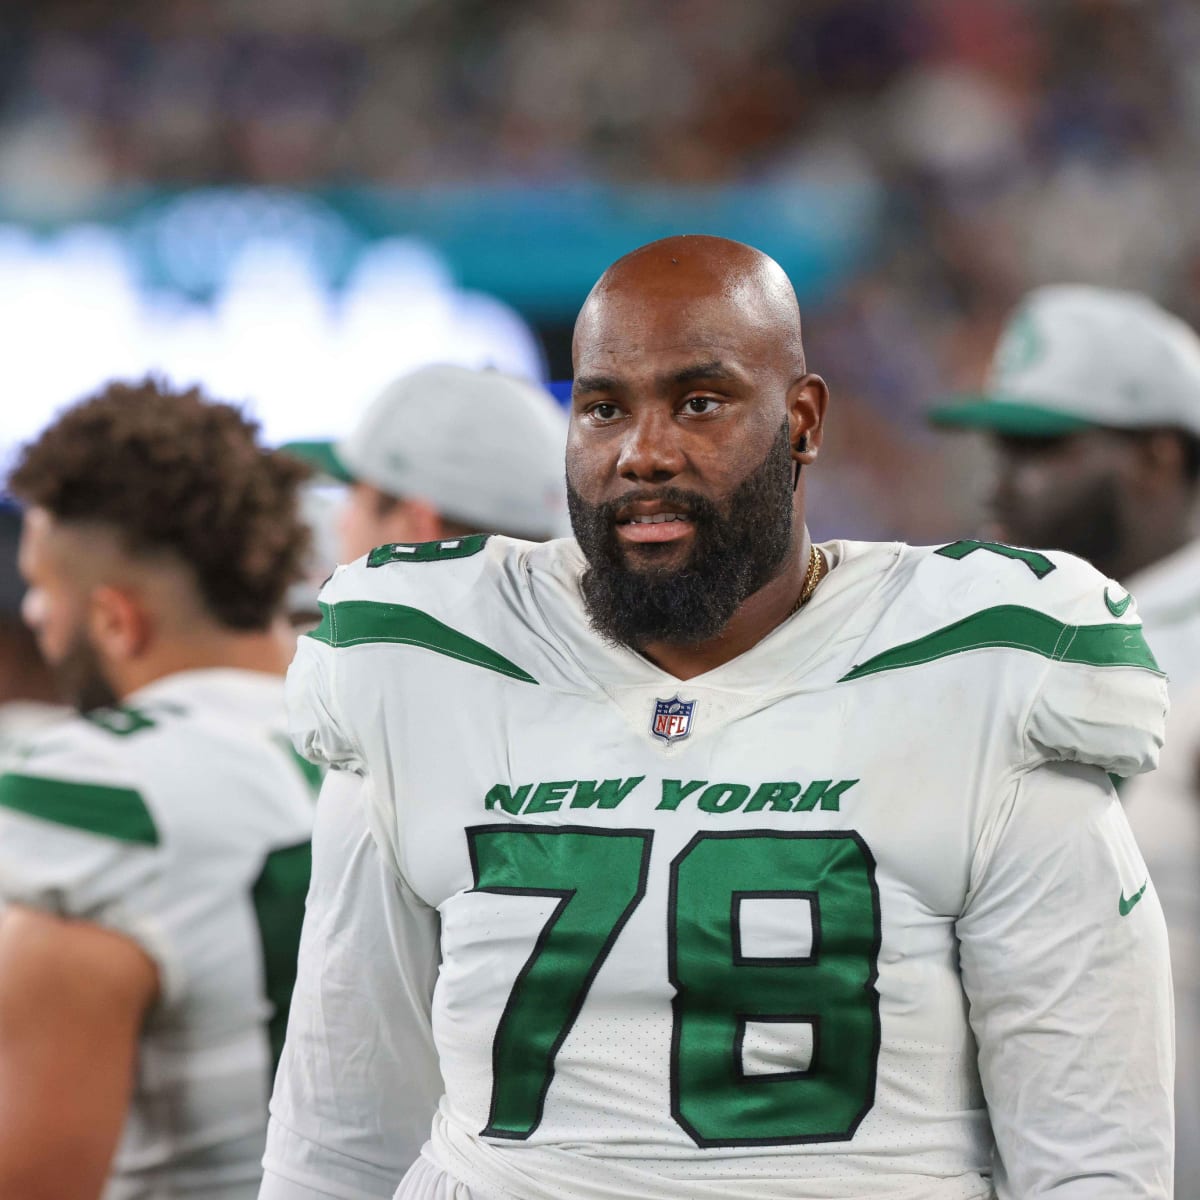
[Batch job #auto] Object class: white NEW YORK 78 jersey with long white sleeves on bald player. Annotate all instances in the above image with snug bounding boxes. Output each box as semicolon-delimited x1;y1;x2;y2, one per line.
270;538;1172;1200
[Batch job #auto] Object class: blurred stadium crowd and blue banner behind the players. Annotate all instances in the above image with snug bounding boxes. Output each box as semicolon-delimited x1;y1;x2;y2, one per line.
0;0;1200;541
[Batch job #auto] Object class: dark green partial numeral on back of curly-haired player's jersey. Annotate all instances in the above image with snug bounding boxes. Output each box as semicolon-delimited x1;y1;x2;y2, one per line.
251;841;312;1079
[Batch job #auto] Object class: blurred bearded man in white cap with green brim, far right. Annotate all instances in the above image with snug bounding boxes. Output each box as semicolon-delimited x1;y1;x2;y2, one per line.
931;286;1200;1196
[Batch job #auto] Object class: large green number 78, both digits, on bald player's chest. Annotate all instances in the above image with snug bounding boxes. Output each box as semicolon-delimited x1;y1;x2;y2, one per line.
467;824;882;1147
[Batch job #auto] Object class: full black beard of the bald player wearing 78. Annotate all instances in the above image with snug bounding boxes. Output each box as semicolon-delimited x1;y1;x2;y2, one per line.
566;424;793;649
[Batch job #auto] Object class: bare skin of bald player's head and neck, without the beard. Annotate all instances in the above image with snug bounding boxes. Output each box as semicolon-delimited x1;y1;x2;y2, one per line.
566;236;829;679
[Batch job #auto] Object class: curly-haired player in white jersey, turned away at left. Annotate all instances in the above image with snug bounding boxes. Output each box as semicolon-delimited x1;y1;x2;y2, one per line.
0;379;313;1200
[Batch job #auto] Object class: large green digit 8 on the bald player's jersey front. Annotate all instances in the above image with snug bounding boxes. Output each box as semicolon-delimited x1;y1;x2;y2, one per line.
667;832;882;1147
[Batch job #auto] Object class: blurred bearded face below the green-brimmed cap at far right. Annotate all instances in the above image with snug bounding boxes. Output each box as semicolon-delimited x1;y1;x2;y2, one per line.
988;428;1194;580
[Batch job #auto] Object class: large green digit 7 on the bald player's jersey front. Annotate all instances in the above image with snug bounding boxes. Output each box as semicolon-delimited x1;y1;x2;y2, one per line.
467;824;654;1140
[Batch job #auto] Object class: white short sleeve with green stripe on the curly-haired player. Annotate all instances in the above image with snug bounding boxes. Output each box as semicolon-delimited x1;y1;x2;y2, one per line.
0;720;182;997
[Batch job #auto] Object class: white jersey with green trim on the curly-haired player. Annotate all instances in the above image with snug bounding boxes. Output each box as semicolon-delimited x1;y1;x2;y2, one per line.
0;670;319;1200
